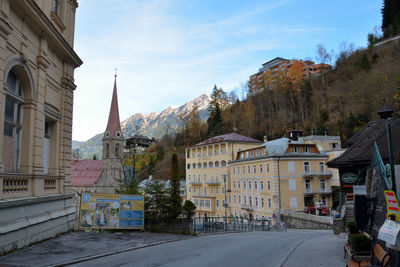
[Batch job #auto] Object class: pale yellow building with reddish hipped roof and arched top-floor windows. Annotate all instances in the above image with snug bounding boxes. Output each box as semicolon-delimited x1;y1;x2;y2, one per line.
185;133;262;220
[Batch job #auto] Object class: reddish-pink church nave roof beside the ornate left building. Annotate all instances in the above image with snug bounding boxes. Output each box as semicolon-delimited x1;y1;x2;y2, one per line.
71;159;103;186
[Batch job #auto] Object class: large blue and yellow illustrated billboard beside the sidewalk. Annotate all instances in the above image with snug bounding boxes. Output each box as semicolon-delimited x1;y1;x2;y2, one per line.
79;193;144;229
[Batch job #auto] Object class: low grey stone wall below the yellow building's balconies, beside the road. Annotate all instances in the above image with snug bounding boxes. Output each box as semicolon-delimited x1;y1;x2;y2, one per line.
281;210;333;230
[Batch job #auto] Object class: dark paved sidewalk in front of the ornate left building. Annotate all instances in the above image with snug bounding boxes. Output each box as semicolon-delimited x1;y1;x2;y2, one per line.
0;232;192;266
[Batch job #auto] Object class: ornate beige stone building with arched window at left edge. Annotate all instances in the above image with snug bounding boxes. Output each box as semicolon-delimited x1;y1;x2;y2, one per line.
0;0;82;253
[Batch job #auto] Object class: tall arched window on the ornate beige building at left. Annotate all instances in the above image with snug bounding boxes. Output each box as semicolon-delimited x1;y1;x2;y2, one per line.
3;70;24;172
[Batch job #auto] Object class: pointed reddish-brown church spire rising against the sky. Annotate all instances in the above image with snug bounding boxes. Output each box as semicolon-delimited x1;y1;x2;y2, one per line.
104;74;123;139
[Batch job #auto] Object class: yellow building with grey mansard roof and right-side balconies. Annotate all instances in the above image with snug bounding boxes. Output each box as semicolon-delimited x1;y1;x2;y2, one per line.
229;131;340;220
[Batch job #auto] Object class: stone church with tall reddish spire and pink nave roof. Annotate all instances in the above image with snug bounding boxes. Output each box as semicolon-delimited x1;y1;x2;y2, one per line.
71;75;125;194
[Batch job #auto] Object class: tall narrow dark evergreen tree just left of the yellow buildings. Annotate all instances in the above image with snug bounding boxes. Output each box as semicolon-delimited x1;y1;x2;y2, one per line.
170;153;182;218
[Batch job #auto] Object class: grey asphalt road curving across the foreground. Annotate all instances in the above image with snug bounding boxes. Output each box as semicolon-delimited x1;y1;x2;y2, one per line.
73;231;346;267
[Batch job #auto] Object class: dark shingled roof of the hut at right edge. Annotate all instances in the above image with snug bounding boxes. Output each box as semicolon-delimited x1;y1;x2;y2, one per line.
328;119;400;168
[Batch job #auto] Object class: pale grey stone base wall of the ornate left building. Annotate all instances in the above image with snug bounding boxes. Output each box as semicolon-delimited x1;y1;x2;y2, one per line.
0;194;76;255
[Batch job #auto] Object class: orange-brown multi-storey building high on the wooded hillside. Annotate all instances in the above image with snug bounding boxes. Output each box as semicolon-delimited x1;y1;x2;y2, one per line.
248;57;332;93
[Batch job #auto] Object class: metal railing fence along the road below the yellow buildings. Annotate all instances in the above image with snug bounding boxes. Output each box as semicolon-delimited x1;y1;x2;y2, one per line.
193;217;286;233
